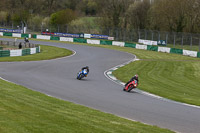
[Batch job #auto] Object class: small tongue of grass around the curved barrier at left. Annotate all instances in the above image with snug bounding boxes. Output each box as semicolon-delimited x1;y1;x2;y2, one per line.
0;45;73;62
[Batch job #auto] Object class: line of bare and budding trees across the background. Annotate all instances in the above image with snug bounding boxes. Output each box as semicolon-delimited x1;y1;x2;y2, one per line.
0;0;200;33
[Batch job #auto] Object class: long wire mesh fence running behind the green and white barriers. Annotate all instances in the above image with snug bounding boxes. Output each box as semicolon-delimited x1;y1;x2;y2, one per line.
1;25;200;51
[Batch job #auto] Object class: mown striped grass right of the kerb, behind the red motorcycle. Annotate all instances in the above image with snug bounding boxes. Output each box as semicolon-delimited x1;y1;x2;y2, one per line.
109;48;200;106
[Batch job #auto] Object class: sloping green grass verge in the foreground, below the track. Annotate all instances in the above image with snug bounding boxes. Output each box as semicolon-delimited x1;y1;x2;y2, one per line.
0;80;171;133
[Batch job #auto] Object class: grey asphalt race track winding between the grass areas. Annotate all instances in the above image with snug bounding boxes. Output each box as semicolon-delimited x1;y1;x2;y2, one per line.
0;38;200;133
